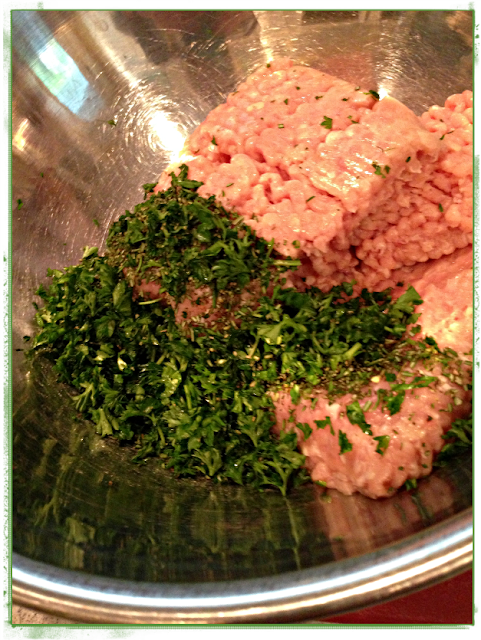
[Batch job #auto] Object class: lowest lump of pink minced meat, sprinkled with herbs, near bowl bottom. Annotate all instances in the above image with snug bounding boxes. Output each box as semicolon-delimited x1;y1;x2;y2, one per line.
275;364;471;498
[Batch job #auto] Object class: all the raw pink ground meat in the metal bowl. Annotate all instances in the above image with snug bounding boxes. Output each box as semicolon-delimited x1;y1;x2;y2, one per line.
155;59;473;498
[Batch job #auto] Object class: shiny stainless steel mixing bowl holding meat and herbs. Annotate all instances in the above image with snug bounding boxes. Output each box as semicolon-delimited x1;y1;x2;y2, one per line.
11;10;472;623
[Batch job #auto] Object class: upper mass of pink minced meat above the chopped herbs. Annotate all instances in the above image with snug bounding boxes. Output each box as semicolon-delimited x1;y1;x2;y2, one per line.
157;59;472;290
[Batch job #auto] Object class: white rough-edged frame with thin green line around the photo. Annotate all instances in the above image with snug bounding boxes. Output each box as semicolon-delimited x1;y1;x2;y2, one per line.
3;0;481;640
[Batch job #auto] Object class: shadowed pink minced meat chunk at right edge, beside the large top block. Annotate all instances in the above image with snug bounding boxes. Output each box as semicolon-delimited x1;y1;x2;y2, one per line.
351;91;473;288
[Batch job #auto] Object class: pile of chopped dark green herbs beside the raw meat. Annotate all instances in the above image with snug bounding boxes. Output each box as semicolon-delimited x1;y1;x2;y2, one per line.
25;165;468;494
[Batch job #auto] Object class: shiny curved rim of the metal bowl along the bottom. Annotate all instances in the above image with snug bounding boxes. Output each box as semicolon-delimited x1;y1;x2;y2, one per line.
12;508;473;624
